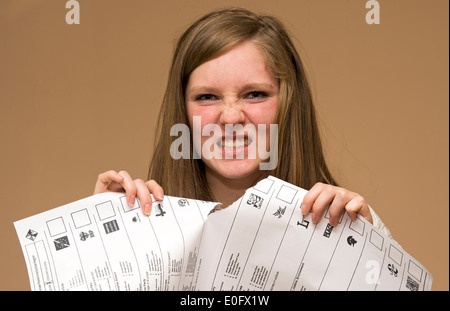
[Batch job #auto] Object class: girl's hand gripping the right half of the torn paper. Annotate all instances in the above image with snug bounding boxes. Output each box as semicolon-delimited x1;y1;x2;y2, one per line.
301;182;373;226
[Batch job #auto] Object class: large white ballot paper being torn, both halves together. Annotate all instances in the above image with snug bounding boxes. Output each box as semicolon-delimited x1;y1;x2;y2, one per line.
14;176;433;291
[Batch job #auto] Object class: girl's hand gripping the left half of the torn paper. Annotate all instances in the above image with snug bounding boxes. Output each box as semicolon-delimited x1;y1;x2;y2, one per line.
94;170;164;215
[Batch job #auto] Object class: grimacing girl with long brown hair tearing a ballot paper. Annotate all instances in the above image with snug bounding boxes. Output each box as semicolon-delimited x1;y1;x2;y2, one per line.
94;8;390;235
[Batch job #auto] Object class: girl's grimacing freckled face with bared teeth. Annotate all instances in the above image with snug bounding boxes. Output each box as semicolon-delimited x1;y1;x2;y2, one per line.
185;41;279;183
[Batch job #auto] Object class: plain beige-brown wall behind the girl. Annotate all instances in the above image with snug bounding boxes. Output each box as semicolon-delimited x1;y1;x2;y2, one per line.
0;0;449;290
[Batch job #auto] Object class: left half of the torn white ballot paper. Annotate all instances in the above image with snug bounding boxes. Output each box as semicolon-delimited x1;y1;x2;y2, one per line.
15;193;216;290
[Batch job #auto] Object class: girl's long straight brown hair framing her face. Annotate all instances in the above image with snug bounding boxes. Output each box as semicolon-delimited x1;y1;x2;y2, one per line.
148;8;336;200
